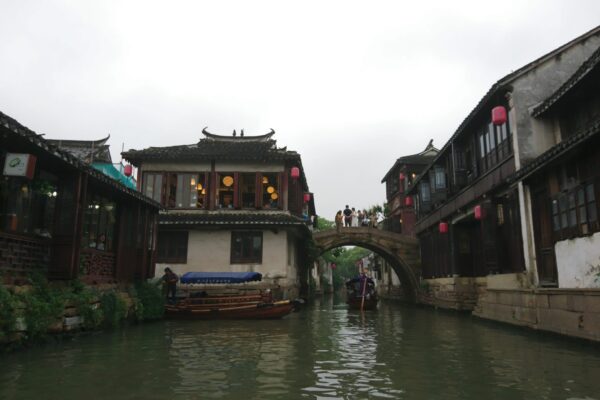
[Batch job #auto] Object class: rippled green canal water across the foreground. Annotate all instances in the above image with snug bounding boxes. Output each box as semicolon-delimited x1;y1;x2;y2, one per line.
0;297;600;400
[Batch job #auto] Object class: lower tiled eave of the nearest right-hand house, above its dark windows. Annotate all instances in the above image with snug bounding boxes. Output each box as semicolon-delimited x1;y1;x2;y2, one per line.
507;119;600;183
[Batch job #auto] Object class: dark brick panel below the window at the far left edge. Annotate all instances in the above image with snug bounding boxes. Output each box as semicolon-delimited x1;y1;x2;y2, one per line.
0;234;50;284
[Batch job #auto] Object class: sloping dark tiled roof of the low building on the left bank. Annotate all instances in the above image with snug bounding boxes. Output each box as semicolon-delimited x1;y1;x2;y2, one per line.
0;112;161;208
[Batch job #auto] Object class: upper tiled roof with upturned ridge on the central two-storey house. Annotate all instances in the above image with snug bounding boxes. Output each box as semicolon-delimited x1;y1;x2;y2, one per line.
123;132;300;165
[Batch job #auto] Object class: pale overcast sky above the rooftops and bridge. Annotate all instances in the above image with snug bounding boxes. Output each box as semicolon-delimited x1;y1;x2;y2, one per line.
0;0;600;219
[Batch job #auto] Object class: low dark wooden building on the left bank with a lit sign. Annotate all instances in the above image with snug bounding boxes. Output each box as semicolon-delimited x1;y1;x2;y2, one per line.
0;109;159;283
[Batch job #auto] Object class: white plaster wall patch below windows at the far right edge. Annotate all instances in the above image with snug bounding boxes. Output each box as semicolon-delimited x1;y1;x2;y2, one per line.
554;232;600;288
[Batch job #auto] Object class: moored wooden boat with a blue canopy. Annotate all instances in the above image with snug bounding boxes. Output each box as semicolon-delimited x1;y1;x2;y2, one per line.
165;272;294;319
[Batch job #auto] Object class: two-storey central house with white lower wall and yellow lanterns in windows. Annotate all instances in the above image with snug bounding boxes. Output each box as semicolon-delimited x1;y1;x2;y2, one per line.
123;129;315;298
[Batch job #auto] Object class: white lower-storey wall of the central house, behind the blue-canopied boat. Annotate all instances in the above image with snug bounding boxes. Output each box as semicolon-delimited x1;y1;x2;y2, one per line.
156;230;299;297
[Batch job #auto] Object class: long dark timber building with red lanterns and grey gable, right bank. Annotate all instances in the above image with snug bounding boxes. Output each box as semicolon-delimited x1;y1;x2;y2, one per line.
408;27;600;309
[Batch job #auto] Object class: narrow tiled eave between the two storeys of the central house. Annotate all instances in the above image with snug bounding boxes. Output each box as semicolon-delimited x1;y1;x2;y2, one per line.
158;210;306;227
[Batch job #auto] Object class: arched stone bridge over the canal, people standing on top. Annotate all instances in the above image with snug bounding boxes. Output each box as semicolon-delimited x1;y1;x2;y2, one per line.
313;227;421;302
